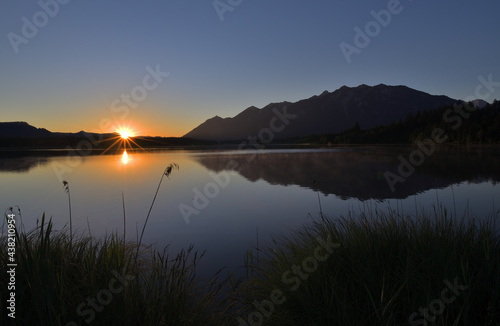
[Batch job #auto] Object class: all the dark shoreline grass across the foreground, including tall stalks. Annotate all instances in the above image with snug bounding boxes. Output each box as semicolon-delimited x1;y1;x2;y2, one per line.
0;165;500;326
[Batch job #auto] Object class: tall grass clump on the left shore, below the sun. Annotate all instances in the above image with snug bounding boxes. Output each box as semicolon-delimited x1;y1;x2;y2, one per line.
0;216;242;325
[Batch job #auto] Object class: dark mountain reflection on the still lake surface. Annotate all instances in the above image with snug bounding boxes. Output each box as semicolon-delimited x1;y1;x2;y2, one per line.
196;146;500;200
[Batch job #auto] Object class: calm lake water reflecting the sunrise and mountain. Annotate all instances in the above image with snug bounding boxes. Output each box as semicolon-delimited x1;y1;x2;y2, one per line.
0;146;500;275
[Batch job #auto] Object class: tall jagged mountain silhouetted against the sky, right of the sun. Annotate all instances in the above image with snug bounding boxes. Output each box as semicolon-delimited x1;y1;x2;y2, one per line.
184;84;457;141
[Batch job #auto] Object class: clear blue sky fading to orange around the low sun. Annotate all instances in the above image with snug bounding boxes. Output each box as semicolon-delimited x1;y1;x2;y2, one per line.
0;0;500;137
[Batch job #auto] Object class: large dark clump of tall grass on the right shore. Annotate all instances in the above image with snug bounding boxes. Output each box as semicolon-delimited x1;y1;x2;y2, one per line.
244;206;500;326
